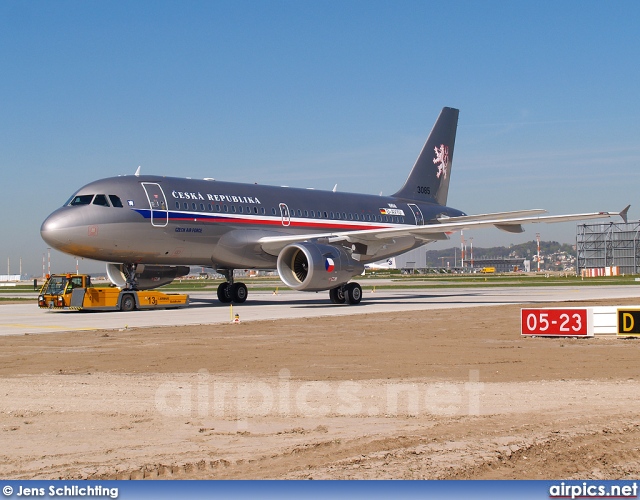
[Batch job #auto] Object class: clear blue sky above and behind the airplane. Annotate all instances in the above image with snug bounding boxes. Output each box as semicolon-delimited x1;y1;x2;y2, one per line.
0;0;640;275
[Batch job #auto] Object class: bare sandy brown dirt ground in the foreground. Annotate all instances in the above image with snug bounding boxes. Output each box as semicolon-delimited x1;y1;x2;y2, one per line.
0;299;640;479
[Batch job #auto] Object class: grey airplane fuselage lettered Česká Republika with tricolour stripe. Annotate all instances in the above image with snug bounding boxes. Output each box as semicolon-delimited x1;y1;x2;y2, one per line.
41;176;464;269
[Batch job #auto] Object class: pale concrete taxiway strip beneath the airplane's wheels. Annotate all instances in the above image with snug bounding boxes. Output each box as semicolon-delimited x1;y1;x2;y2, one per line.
0;286;640;335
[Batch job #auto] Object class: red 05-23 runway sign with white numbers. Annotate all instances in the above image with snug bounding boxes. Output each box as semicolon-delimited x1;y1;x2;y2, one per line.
520;308;589;337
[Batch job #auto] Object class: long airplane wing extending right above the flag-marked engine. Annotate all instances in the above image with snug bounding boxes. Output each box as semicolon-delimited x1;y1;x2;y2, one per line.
258;206;629;260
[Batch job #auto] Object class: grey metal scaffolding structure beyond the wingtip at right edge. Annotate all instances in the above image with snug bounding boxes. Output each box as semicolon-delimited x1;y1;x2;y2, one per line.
576;221;640;274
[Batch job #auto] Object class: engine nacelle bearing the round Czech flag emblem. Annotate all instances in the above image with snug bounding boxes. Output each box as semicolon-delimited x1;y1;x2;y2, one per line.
278;243;364;292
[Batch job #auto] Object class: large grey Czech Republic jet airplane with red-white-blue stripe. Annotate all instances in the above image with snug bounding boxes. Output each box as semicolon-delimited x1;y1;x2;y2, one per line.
40;107;629;304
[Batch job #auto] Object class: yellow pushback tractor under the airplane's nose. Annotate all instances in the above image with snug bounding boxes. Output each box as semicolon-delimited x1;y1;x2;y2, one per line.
38;274;189;311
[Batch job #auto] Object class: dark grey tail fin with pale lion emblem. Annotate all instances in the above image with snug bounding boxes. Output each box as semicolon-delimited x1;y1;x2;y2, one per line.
392;108;459;205
